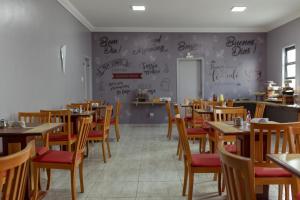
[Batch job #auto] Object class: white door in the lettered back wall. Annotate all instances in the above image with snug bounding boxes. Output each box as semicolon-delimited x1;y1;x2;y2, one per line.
177;59;203;104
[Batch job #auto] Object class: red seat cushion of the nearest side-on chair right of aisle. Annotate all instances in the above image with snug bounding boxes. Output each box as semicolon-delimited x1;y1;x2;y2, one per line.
192;153;221;167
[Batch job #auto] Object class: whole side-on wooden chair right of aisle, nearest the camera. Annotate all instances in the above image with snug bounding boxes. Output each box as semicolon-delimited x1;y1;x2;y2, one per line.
176;115;221;200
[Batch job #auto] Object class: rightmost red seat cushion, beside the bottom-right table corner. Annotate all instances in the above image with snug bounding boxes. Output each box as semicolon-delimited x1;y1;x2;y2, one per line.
255;167;292;177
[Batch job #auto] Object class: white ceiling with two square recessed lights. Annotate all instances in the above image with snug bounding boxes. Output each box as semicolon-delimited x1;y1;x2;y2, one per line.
58;0;300;32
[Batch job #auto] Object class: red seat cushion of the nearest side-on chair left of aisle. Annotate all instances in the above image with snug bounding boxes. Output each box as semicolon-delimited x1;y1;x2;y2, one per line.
33;150;73;164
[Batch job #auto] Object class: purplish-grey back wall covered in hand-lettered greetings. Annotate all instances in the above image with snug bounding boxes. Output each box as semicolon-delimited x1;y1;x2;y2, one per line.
92;33;266;123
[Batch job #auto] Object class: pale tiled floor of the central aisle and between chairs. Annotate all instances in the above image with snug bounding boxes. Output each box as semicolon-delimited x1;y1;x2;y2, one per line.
41;125;277;200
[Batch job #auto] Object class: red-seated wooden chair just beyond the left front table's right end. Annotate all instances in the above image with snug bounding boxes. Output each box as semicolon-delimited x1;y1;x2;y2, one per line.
41;110;77;152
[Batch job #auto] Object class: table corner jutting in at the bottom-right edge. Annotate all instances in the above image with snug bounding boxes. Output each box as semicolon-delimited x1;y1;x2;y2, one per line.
267;153;300;199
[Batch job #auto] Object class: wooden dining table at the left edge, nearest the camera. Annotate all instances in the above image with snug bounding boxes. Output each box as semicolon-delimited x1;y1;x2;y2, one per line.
0;123;64;155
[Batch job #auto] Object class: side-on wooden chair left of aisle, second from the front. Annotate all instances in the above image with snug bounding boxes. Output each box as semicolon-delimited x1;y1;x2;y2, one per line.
87;105;112;163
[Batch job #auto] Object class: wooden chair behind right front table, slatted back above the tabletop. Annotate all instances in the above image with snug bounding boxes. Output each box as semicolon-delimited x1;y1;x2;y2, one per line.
209;107;247;153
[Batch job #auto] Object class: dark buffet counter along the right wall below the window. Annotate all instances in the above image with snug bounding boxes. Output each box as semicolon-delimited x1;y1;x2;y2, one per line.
234;100;300;122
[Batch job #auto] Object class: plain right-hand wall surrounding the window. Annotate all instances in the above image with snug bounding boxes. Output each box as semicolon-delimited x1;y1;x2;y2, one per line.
267;19;300;88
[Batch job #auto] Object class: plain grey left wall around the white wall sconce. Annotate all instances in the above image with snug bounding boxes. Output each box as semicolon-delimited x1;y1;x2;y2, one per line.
0;0;91;152
